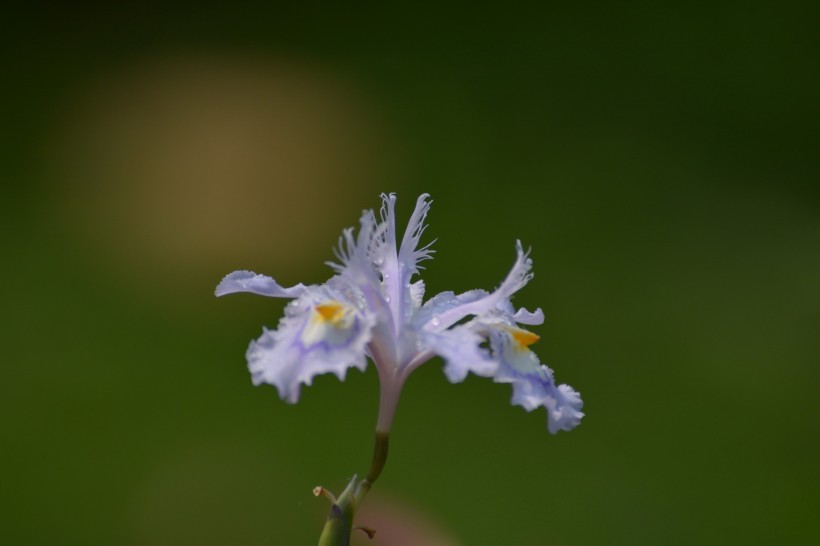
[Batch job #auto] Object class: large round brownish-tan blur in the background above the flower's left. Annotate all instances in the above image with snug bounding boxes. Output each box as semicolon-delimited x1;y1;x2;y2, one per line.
45;54;394;300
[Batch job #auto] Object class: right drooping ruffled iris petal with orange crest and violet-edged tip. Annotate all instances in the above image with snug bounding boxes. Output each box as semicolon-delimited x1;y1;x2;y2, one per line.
489;324;584;434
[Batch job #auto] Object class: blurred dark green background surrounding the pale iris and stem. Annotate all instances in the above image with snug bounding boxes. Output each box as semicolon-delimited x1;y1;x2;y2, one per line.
0;1;820;546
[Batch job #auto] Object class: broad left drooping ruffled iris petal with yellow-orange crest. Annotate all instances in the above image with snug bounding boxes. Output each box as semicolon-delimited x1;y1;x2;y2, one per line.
246;288;375;403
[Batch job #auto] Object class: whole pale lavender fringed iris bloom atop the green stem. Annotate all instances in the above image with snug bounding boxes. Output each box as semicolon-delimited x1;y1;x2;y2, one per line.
216;194;584;434
